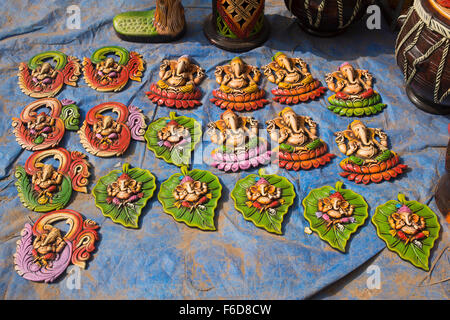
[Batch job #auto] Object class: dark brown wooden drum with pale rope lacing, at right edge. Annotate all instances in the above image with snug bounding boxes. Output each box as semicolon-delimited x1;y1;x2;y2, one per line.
395;0;450;114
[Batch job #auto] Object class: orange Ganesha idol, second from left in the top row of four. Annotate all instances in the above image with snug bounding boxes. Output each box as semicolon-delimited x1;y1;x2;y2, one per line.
210;57;269;111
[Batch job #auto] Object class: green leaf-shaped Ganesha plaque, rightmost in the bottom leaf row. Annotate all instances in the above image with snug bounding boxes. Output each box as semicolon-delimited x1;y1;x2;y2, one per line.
372;194;440;271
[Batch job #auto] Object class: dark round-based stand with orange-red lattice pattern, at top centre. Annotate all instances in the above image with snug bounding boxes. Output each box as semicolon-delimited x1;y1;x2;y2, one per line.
203;0;270;52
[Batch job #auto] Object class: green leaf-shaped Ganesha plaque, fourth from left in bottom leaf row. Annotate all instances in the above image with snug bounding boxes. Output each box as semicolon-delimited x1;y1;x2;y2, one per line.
303;181;369;252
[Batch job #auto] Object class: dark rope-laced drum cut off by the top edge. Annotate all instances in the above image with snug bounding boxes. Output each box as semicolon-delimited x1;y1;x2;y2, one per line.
284;0;369;37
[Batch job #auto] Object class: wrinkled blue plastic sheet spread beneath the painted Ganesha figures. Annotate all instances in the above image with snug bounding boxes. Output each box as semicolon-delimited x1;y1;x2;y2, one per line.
0;0;449;299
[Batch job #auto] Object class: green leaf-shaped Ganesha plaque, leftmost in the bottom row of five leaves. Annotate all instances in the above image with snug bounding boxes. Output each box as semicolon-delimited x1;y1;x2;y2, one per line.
92;163;156;228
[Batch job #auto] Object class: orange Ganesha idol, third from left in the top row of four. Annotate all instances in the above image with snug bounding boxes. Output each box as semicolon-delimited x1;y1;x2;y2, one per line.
263;52;326;104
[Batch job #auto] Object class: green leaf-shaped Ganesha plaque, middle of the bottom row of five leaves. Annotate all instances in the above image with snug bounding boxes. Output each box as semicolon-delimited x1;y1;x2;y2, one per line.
231;169;295;234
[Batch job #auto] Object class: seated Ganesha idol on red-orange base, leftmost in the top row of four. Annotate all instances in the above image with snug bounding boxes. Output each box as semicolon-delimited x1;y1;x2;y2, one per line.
146;55;205;109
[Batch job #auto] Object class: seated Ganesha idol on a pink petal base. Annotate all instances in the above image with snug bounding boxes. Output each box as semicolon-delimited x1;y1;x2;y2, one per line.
207;110;270;172
